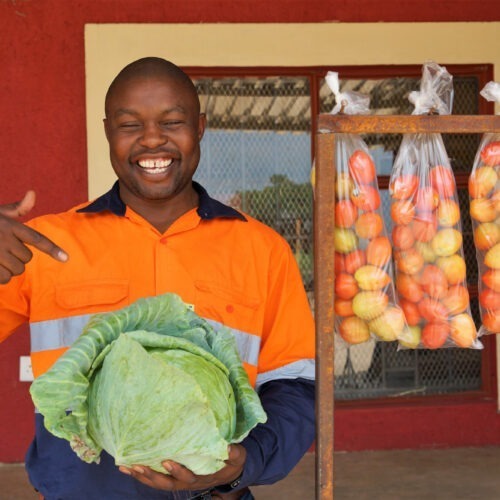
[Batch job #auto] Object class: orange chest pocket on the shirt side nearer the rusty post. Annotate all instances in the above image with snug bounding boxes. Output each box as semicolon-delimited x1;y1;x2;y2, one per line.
194;280;262;334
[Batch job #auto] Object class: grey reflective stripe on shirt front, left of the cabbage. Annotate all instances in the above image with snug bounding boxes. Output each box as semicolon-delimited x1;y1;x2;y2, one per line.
30;314;92;352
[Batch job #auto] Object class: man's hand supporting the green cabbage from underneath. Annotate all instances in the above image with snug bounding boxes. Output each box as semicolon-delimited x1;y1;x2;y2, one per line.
120;444;247;491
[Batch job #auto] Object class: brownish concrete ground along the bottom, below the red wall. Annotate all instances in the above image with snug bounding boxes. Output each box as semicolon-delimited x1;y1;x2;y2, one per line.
0;447;500;500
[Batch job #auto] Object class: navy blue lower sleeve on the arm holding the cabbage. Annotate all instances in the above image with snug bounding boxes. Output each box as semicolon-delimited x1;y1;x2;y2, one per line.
239;378;315;487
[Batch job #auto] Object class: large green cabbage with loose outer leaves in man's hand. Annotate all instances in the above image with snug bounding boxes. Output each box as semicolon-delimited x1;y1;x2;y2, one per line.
30;294;267;474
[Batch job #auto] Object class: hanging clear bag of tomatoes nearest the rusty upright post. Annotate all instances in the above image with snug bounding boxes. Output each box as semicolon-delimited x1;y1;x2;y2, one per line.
326;72;407;346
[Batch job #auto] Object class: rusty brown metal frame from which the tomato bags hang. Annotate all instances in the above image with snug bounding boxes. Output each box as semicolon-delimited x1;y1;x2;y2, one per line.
314;114;500;500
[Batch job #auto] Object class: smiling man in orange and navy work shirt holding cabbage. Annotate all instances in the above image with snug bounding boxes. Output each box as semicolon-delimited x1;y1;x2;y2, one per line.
0;57;315;500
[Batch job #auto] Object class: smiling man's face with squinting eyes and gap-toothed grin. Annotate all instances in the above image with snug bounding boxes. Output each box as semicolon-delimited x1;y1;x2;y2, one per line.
105;77;205;208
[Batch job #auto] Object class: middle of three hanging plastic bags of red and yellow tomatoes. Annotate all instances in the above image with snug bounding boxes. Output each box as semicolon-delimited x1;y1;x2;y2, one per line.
389;62;482;349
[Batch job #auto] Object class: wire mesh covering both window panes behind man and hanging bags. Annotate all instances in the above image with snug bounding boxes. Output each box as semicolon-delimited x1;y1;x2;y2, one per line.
195;72;482;400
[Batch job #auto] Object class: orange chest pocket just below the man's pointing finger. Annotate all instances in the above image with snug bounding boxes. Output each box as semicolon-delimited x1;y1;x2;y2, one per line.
56;279;129;313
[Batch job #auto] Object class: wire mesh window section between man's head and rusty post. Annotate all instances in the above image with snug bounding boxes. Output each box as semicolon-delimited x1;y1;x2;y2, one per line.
195;77;313;290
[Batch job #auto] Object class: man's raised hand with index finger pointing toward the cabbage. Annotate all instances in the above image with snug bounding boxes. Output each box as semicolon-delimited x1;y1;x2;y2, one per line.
0;191;68;284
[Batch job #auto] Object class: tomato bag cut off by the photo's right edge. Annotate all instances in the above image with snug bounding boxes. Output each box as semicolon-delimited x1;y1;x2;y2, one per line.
469;82;500;336
